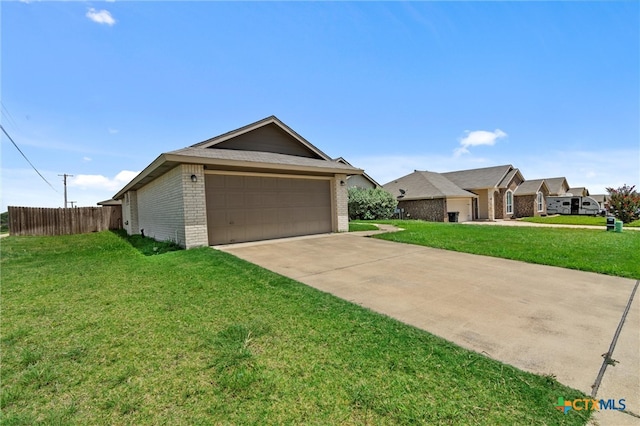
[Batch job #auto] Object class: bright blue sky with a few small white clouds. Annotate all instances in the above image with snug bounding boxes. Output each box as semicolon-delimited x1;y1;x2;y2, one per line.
0;1;640;211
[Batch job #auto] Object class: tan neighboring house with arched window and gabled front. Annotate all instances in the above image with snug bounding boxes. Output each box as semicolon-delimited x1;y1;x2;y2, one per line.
441;164;524;220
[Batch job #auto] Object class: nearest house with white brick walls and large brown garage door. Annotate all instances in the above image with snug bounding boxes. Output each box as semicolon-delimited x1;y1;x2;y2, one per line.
113;116;363;248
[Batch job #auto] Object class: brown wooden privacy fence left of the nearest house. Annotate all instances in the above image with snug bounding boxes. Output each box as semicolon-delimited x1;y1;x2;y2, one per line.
9;206;122;235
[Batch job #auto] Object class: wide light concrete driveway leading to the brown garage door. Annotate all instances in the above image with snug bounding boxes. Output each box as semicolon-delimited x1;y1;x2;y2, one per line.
218;233;640;424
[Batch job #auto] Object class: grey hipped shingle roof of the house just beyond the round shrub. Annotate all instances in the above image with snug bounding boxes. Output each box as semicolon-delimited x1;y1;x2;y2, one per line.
382;170;476;200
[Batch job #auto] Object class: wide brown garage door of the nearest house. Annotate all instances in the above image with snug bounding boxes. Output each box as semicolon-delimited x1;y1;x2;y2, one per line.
205;175;331;245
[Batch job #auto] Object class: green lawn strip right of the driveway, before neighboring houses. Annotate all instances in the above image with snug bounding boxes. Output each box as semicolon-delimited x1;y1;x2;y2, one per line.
376;220;640;279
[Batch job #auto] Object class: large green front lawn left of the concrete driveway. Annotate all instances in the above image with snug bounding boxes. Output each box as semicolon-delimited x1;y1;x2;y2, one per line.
0;232;588;425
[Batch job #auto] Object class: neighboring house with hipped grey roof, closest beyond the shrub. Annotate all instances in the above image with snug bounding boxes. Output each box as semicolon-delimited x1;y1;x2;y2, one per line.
383;170;477;222
